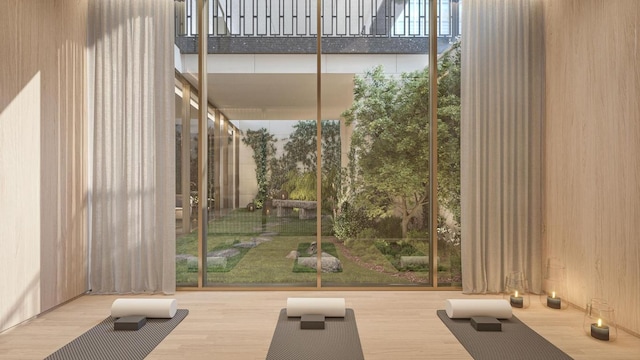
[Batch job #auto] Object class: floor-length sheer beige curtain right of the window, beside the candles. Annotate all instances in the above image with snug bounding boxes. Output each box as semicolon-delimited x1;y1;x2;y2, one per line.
461;0;544;293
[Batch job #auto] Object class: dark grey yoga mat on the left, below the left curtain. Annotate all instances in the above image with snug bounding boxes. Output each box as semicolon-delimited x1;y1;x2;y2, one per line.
45;309;189;360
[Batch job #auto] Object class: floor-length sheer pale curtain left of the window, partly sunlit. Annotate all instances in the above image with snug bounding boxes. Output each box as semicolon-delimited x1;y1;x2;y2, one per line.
87;0;175;293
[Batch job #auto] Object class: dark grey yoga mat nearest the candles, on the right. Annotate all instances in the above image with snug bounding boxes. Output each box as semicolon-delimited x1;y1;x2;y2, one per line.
437;310;572;360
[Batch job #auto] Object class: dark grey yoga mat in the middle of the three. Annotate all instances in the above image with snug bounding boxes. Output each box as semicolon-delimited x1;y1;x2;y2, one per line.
267;309;364;360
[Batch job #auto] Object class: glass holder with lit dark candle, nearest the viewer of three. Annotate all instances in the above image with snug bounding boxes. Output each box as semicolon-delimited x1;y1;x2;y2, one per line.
582;299;618;341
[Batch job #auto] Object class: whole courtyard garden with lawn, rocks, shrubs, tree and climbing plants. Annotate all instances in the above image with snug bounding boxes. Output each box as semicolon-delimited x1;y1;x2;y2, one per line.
176;43;461;286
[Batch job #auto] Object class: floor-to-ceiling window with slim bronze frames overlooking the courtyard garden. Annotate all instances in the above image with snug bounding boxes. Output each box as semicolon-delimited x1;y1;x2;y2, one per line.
170;0;460;288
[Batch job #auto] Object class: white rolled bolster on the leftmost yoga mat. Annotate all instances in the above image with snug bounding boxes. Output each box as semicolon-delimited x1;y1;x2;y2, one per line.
111;298;178;319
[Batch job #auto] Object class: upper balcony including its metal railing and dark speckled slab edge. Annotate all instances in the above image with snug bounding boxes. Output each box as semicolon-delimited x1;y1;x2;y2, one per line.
175;0;460;54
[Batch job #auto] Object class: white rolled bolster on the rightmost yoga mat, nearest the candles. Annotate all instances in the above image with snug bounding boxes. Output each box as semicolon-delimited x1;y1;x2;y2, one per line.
445;299;513;319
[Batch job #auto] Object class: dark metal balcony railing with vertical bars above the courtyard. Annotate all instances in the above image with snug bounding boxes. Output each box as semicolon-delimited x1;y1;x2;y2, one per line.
175;0;460;38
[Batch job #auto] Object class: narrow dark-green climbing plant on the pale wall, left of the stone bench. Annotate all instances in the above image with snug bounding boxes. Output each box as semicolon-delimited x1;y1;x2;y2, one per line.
242;128;276;209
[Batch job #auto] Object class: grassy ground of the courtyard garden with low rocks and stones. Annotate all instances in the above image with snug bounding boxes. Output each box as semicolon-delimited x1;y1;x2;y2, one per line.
176;209;457;287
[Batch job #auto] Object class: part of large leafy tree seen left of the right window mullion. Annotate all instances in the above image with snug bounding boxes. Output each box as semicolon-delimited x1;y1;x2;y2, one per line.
343;66;429;237
